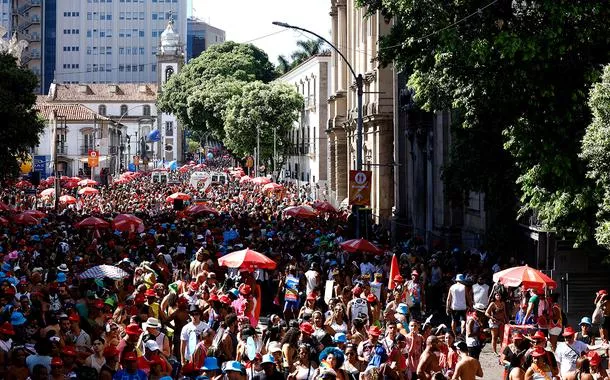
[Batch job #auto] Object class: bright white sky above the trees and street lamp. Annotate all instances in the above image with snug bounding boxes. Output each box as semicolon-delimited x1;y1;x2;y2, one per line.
192;0;331;64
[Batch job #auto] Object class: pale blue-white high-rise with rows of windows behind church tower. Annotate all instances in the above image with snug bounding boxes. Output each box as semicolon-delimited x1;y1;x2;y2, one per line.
54;0;187;84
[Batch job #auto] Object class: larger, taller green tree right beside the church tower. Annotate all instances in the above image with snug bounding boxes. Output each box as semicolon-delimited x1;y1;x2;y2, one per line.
157;41;276;140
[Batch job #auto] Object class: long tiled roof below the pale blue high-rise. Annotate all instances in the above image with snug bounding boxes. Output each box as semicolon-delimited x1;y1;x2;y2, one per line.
49;83;157;102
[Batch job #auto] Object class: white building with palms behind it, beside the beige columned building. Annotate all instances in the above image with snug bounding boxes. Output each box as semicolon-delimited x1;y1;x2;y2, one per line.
277;55;331;198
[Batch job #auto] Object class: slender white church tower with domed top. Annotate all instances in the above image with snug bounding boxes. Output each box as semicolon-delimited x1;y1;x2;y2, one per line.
157;17;186;163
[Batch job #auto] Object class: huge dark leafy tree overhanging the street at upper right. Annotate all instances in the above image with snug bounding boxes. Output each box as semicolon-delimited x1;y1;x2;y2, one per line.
359;0;610;246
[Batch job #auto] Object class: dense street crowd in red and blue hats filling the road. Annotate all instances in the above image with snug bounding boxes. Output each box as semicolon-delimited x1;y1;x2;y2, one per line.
0;155;610;380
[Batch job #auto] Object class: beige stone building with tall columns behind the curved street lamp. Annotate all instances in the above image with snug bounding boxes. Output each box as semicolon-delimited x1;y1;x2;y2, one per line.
327;0;394;227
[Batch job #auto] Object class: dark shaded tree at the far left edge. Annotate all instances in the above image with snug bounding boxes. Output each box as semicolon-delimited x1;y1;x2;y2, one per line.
0;54;44;180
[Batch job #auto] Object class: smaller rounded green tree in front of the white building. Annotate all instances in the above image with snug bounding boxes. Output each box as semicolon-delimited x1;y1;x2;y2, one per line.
224;82;303;165
